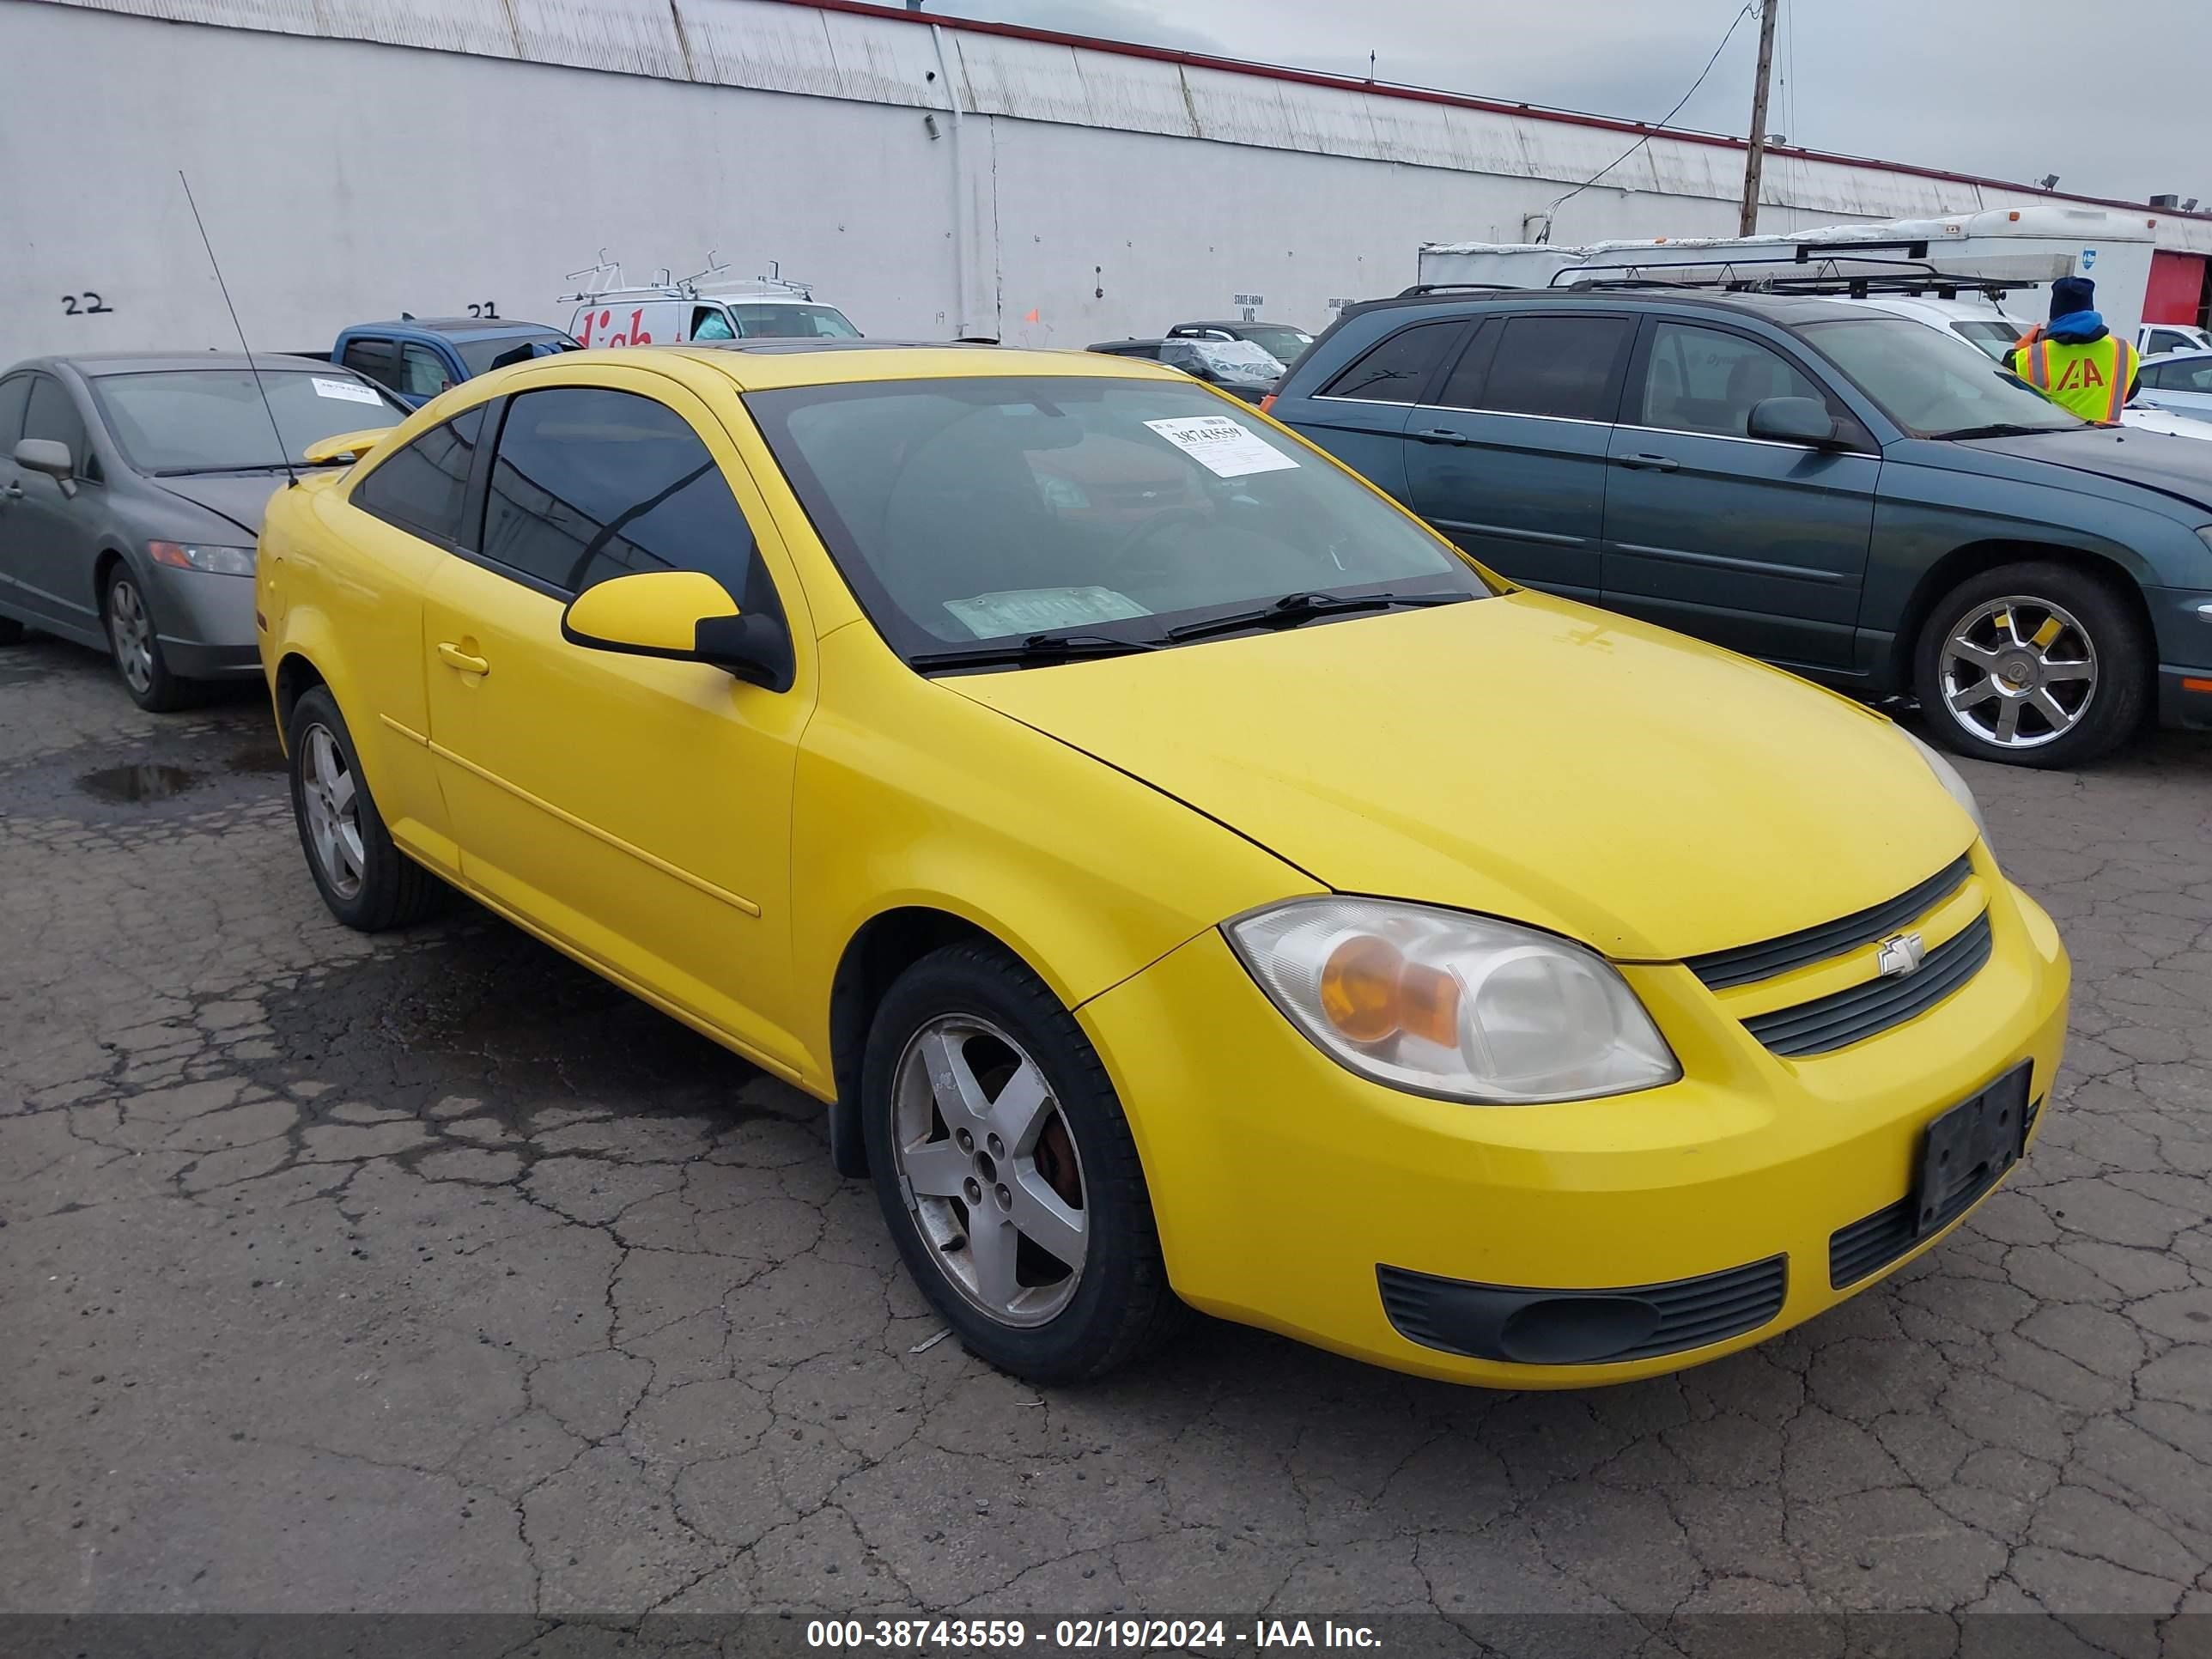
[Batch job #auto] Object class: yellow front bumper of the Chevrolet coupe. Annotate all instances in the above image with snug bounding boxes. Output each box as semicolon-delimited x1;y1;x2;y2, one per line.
1078;852;2069;1387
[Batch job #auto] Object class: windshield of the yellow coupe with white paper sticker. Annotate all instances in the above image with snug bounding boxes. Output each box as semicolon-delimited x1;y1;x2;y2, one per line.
745;376;1493;657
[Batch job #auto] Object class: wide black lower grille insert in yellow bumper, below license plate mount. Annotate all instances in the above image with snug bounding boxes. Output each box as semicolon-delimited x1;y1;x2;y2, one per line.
1376;1256;1790;1364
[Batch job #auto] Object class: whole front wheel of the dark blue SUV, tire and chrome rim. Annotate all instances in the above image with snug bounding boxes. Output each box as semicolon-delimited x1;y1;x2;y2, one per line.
1916;564;2148;768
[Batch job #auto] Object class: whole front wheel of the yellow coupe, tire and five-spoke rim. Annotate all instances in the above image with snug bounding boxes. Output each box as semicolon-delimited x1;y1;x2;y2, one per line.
860;942;1183;1382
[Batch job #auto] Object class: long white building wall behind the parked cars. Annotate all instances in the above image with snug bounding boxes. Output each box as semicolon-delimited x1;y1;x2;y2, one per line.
0;0;2212;362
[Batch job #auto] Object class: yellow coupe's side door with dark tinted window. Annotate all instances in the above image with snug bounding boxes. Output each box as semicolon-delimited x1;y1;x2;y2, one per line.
422;368;811;1066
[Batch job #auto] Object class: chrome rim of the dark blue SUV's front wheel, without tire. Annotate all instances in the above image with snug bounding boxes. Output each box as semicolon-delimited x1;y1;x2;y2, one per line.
1938;595;2097;750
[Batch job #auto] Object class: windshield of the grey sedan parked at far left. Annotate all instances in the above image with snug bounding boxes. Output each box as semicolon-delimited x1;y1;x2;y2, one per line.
93;369;407;473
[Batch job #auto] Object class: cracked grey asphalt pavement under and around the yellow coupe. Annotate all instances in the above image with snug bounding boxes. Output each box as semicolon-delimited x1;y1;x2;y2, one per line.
0;639;2212;1614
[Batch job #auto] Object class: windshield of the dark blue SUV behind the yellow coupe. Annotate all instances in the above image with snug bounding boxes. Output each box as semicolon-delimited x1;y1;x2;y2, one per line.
1798;316;2086;438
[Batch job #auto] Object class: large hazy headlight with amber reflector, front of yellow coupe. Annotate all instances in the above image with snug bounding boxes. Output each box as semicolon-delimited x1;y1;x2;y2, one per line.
1224;898;1681;1106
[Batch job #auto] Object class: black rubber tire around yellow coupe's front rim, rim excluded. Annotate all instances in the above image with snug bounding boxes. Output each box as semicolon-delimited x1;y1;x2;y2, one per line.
860;942;1188;1382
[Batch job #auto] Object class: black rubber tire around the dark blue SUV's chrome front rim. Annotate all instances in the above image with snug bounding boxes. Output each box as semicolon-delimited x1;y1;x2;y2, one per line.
1913;560;2152;768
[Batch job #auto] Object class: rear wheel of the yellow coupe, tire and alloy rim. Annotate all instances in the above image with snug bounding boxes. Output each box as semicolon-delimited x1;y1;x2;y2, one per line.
285;686;445;933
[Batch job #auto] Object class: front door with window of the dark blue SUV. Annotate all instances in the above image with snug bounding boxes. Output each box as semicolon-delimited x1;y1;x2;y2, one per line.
1604;319;1882;668
